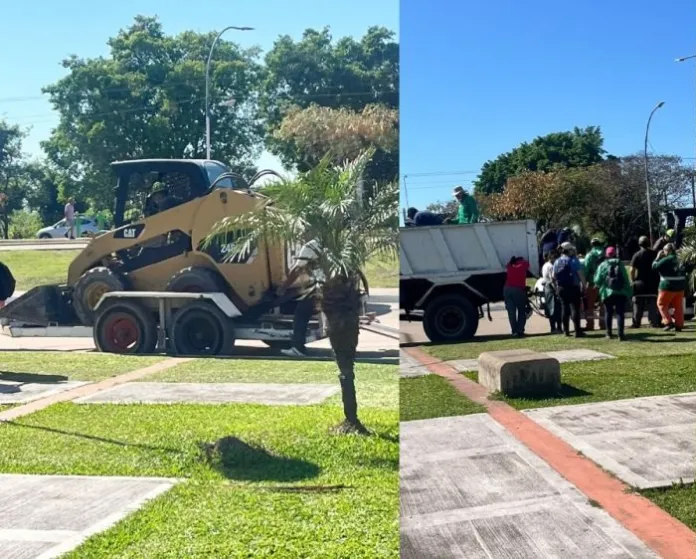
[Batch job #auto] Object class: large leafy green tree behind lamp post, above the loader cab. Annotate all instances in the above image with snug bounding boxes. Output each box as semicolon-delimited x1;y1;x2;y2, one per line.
43;16;262;212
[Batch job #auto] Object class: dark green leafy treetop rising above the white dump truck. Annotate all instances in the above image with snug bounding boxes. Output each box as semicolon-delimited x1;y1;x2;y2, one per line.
474;126;606;194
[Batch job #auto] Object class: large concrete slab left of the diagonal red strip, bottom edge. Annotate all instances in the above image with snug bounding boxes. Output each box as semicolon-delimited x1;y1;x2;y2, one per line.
400;414;657;559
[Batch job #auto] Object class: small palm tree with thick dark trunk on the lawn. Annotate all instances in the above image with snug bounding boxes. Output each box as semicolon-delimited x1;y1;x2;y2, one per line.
210;150;399;433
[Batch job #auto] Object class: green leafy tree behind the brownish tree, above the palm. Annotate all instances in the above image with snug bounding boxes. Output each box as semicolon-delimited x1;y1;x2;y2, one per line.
260;27;399;177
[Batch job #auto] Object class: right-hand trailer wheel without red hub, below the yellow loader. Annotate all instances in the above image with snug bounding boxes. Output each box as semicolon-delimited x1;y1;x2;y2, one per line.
170;301;235;355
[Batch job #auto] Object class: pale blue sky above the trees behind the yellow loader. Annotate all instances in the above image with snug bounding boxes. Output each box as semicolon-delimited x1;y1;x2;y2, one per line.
0;0;399;169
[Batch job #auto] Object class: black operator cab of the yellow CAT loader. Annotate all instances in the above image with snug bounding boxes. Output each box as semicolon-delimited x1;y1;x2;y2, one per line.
111;159;236;228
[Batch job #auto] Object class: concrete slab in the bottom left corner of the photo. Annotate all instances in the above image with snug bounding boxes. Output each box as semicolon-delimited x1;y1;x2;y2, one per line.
0;474;176;559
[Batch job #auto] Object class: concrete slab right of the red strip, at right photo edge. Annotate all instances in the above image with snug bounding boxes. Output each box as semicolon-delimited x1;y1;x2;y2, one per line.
525;394;696;489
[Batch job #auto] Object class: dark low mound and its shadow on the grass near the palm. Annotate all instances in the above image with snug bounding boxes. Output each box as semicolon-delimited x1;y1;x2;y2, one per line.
199;437;321;483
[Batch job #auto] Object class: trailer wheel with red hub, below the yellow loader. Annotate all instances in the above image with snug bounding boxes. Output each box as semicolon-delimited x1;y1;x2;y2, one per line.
93;301;157;355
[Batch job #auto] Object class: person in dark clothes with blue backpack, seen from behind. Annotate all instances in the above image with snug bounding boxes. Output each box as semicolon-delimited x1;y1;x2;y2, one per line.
553;242;585;338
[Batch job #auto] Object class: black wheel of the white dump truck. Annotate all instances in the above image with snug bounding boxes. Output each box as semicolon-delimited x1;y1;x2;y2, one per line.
423;295;478;342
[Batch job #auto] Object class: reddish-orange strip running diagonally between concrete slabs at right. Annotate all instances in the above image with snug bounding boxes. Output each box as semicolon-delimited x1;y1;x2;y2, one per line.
402;347;696;559
